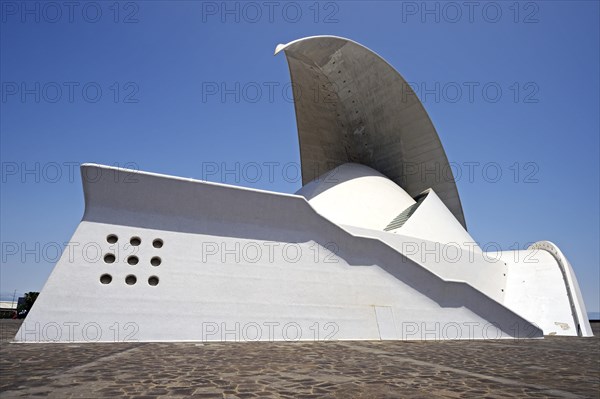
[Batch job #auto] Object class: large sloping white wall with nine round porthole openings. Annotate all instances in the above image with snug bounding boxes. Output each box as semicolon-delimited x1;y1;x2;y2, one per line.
15;165;541;342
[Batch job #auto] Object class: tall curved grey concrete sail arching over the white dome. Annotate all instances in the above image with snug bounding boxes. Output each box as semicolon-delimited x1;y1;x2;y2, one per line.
275;36;466;228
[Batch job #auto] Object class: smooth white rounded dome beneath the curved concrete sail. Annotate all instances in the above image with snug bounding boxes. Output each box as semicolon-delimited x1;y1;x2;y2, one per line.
296;163;415;230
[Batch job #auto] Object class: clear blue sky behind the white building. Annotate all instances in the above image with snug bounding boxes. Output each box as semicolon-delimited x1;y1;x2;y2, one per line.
0;0;600;318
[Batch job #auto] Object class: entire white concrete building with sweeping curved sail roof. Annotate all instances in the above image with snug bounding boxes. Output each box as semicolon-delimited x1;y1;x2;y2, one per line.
15;36;592;342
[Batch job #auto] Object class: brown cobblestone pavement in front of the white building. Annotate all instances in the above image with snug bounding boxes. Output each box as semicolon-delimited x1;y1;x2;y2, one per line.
0;320;600;398
